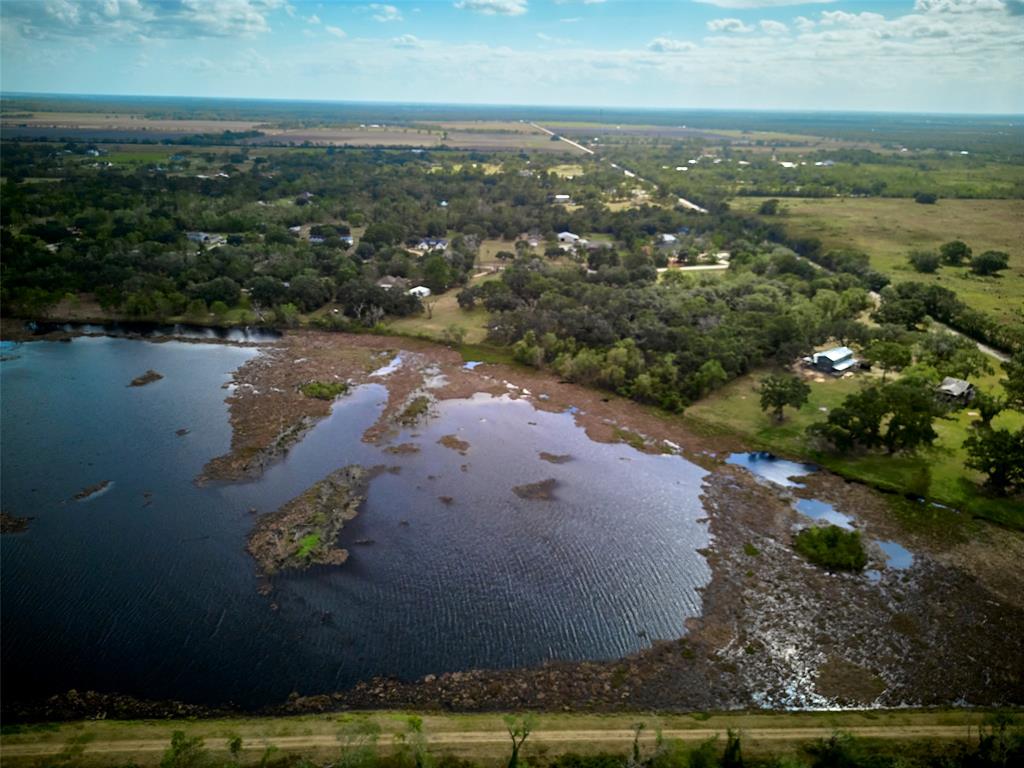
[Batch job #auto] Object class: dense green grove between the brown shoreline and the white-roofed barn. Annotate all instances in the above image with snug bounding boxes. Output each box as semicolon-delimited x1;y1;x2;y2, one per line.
477;240;868;411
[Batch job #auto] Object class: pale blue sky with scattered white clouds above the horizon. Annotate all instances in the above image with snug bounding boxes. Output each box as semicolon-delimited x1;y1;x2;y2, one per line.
0;0;1024;114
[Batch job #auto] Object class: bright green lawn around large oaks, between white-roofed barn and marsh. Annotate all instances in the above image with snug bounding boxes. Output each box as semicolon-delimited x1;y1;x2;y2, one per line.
684;360;1024;529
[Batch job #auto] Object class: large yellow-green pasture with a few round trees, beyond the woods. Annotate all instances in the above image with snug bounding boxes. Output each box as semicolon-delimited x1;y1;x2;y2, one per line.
732;198;1024;322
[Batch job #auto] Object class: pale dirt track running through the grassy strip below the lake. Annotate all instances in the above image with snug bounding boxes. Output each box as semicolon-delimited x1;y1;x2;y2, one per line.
0;725;969;759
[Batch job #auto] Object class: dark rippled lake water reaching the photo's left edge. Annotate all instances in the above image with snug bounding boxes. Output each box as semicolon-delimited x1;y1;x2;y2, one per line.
0;338;710;706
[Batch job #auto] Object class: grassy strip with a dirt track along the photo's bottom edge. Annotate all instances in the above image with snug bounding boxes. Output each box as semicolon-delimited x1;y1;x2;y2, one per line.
0;710;1011;766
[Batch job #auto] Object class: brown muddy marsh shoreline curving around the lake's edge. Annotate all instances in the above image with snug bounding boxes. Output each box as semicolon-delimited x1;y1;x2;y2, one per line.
4;331;1024;719
